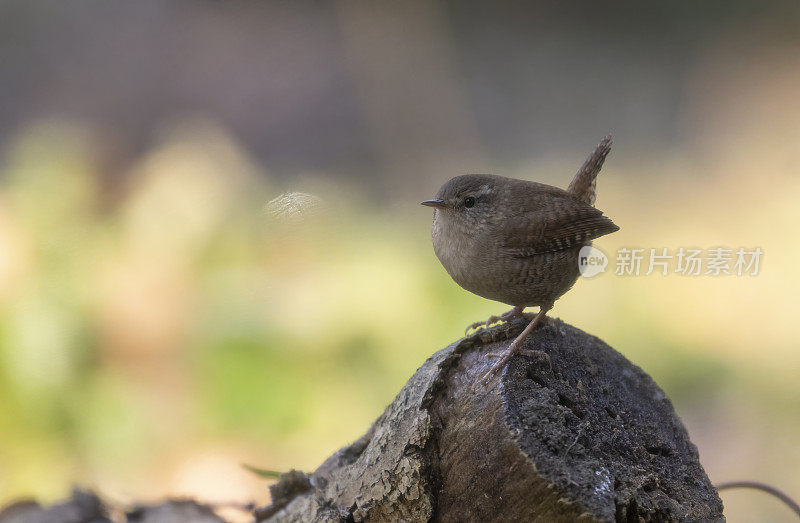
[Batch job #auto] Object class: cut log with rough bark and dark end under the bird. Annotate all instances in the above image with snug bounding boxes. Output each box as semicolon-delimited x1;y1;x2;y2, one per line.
256;318;724;522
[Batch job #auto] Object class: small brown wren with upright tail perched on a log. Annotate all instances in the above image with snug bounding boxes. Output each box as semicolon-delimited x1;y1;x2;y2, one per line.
422;136;619;380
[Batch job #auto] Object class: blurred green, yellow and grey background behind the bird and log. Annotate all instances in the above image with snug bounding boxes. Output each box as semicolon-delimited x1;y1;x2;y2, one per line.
0;0;800;522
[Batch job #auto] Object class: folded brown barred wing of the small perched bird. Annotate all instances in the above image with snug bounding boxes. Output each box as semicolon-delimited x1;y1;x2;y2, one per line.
501;196;619;257
